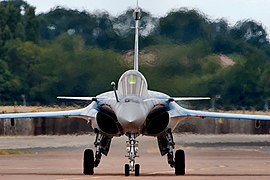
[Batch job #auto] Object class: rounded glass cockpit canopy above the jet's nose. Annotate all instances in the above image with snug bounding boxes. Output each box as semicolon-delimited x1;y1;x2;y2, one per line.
118;70;148;97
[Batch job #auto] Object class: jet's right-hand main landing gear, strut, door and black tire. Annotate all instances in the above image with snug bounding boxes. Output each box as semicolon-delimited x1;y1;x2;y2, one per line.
157;129;186;175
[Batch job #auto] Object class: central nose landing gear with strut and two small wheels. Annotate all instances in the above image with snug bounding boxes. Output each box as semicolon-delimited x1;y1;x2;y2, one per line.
124;134;140;176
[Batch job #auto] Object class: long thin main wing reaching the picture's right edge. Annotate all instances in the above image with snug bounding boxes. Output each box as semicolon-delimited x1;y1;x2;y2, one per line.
172;105;270;121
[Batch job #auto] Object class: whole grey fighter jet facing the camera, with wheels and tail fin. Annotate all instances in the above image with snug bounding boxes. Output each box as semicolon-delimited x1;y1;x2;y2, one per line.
0;3;270;176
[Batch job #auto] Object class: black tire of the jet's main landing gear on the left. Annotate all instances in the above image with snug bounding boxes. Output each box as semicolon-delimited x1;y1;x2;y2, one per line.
83;149;94;175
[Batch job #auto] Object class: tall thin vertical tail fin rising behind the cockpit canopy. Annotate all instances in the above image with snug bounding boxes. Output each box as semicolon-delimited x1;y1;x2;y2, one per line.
133;0;141;71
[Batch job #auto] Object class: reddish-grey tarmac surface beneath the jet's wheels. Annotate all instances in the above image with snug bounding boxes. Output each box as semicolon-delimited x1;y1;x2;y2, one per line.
0;134;270;180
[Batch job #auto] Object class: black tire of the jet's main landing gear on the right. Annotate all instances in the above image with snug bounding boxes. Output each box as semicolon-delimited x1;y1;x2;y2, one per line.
175;149;186;176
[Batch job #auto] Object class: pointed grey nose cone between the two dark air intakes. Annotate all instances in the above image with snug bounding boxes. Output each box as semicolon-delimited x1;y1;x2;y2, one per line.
116;103;147;133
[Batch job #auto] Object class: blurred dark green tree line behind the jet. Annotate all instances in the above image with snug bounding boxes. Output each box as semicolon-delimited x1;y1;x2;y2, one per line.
0;0;270;109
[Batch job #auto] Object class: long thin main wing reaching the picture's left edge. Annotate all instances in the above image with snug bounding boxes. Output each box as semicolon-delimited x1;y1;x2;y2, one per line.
0;109;84;119
